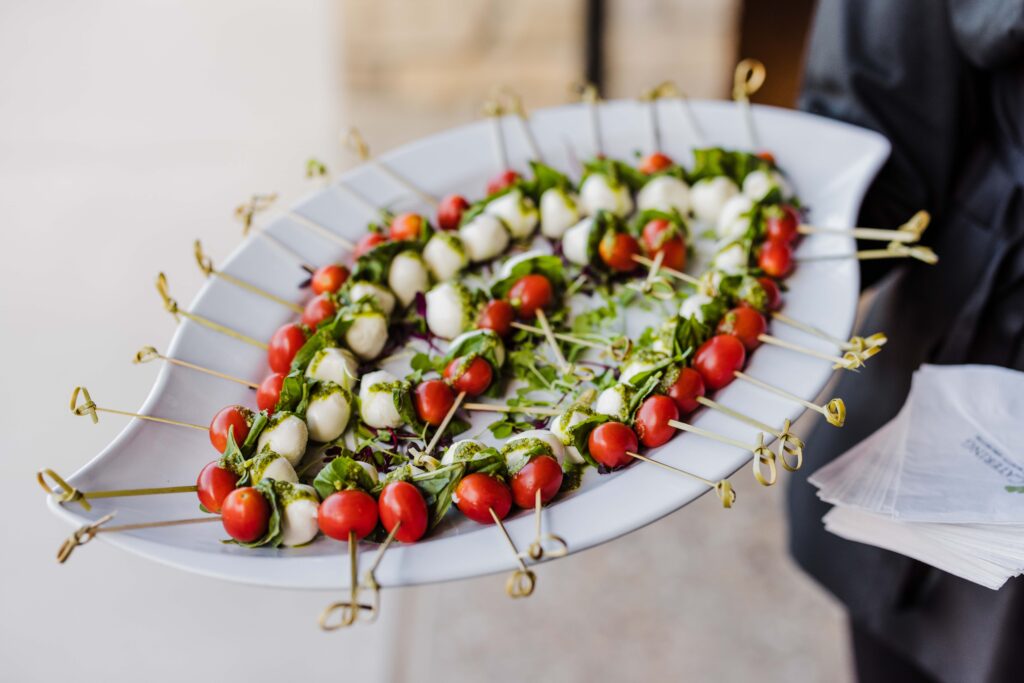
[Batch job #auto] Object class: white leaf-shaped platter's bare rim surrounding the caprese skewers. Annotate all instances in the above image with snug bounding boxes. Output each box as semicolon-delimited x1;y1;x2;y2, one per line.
49;100;889;589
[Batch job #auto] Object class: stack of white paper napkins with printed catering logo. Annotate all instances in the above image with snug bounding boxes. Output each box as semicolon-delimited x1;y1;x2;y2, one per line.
810;366;1024;590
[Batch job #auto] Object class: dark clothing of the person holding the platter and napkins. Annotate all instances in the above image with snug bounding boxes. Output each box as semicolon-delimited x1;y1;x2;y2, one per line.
790;0;1024;683
